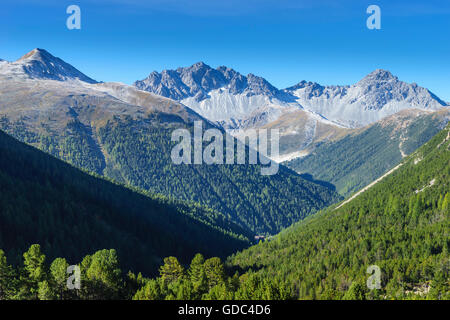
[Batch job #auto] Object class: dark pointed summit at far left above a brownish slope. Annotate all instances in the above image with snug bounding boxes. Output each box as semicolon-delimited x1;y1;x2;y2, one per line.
0;48;97;83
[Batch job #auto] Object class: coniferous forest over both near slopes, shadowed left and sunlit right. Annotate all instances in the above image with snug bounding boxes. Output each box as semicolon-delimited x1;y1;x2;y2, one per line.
0;121;450;300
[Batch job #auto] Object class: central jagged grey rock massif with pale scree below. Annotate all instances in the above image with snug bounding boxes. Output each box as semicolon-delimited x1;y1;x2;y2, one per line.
134;62;285;123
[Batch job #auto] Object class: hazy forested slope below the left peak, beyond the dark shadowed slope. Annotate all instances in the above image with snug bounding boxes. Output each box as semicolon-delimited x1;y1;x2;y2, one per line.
0;87;340;234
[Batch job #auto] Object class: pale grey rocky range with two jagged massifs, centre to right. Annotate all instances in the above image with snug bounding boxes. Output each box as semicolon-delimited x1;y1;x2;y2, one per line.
134;62;447;129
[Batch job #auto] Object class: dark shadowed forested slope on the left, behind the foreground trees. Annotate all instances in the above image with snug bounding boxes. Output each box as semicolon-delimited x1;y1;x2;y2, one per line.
0;128;252;274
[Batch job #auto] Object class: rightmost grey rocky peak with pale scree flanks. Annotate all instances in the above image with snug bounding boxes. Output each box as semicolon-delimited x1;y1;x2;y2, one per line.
285;69;447;127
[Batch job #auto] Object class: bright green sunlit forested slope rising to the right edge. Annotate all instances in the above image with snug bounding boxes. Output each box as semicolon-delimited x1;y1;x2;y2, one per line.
228;125;450;299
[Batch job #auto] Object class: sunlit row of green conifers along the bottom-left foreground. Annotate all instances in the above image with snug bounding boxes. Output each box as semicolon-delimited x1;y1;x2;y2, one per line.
0;244;293;300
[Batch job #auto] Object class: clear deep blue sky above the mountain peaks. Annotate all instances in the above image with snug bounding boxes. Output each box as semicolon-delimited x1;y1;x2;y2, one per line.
0;0;450;101
